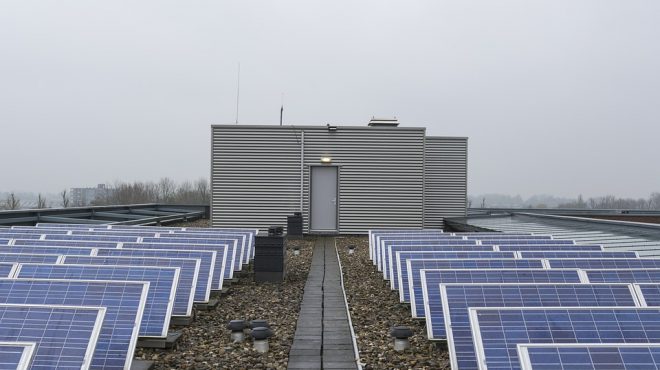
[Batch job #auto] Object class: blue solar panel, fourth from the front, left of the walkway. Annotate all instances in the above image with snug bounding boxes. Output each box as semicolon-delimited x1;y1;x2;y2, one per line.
15;264;180;338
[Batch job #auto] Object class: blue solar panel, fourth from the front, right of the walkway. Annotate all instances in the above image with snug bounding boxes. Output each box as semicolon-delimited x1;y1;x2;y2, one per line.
418;269;584;318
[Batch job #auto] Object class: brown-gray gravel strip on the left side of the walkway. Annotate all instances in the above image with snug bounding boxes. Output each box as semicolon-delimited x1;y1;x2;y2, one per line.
136;236;314;370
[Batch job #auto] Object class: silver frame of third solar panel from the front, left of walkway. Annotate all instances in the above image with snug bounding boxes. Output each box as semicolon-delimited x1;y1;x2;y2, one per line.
0;278;150;369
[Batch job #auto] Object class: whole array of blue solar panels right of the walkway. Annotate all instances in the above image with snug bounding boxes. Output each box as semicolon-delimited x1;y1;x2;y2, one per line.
369;230;660;370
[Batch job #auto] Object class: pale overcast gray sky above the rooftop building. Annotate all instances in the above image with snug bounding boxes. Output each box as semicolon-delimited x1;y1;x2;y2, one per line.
0;0;660;197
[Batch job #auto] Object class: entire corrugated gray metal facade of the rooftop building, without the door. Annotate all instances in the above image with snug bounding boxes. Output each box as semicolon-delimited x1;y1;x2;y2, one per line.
211;125;467;234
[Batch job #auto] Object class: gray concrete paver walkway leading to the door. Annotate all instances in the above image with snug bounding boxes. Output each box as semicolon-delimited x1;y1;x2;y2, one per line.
288;237;357;370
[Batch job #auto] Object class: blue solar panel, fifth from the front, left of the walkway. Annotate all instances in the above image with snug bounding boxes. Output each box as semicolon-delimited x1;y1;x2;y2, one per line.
62;256;200;316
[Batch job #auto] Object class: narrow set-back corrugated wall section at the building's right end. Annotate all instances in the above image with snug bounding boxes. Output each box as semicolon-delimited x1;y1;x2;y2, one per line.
424;136;467;228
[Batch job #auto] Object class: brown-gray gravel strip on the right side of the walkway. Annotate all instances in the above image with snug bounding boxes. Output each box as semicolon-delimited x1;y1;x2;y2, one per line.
337;236;450;369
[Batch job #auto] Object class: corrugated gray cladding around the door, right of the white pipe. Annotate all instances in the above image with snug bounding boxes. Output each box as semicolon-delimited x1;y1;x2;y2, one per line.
303;126;425;234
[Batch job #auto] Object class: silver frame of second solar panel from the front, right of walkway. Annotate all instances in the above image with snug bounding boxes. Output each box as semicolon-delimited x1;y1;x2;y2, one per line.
469;306;660;369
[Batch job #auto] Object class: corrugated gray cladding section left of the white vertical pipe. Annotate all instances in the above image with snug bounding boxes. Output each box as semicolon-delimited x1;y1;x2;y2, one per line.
211;126;300;229
